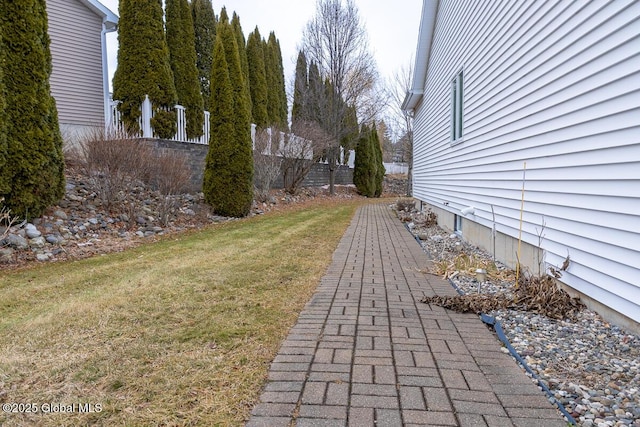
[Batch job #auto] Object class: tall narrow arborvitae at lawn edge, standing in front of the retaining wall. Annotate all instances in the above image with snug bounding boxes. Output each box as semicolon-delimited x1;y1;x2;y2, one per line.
205;16;253;217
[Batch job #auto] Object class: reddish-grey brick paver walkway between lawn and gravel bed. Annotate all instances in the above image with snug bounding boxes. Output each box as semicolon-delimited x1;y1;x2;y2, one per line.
247;204;567;427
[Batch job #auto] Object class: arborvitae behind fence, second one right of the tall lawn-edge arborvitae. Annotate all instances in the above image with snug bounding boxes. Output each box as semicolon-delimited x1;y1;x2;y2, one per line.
265;31;288;128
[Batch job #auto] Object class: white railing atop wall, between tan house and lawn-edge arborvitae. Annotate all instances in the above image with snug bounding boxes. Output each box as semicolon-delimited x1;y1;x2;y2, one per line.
109;95;210;144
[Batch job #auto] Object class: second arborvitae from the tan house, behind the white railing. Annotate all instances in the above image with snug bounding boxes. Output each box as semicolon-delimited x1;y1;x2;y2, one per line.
166;0;204;138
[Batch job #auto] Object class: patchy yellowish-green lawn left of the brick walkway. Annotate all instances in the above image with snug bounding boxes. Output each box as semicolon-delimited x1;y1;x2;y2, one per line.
0;202;358;426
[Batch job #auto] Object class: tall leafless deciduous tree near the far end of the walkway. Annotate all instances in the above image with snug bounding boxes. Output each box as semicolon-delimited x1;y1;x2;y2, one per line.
302;0;383;194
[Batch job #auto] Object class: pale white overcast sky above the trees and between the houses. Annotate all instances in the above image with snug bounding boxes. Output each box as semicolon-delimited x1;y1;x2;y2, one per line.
100;0;422;95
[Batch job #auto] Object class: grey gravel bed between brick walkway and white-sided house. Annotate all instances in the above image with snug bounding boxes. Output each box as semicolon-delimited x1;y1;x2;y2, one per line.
393;205;640;427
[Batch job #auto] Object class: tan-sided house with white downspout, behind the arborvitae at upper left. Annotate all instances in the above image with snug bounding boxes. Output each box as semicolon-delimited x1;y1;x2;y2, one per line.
47;0;118;141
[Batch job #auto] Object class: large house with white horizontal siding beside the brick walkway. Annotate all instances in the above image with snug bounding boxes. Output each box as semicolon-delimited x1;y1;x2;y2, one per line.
403;0;640;331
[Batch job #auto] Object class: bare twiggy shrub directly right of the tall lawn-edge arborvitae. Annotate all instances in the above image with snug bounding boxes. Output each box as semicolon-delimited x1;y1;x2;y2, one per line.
253;129;282;202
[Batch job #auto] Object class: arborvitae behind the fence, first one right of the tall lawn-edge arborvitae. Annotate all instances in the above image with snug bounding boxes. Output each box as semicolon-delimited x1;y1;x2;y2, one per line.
247;27;269;128
